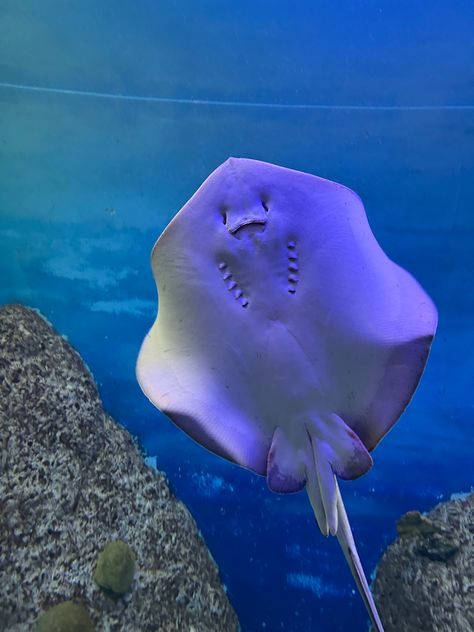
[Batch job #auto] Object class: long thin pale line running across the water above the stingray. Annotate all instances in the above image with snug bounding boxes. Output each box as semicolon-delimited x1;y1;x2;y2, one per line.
0;81;474;112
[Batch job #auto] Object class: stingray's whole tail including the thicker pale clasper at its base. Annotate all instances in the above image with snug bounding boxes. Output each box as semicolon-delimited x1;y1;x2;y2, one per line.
306;450;384;632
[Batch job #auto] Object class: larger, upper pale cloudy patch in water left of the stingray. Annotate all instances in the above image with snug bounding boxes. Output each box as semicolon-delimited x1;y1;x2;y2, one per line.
44;255;133;290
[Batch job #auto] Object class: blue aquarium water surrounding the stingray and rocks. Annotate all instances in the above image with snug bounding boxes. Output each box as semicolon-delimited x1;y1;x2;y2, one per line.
0;0;474;632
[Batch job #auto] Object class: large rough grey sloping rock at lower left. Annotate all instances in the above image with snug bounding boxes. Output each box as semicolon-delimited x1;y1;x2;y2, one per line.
0;305;238;632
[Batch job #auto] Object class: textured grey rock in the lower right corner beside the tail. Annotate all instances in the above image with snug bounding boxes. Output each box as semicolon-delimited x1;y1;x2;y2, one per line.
373;494;474;632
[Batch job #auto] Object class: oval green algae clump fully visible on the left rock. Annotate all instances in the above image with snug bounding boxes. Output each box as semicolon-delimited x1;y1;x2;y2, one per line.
94;540;135;598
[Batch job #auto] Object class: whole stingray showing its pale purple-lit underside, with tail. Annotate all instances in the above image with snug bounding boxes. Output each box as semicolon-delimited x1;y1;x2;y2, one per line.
137;158;437;631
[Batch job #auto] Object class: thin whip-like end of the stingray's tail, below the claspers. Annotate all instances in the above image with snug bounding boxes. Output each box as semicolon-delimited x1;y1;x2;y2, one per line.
336;483;384;632
